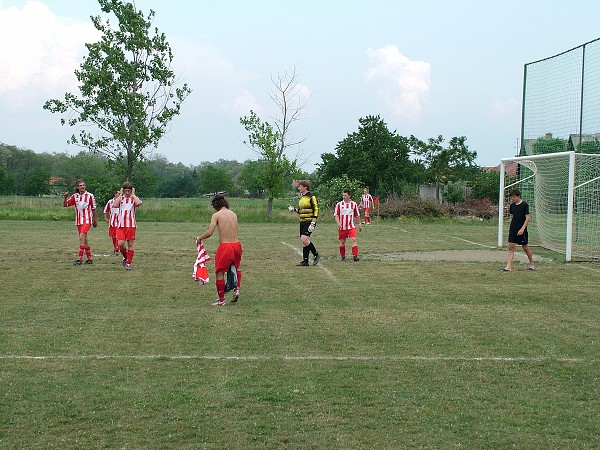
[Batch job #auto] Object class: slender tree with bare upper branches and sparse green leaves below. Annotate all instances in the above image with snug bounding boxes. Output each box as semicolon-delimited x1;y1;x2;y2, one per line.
240;70;307;217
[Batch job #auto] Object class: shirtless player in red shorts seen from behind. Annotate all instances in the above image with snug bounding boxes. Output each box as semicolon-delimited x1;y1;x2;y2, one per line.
196;194;242;306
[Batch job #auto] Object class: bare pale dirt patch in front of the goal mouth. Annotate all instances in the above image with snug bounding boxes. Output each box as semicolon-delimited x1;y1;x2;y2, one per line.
365;250;536;262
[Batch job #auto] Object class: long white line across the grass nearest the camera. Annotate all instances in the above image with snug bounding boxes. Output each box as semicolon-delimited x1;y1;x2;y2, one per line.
0;355;600;363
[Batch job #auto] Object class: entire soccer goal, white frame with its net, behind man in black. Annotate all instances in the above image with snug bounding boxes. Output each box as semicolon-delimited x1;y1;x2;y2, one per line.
498;151;600;261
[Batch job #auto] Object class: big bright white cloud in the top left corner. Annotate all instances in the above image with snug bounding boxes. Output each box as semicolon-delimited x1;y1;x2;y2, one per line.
0;0;98;95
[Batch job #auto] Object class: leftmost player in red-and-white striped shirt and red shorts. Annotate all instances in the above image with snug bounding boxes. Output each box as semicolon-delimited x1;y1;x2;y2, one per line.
63;180;98;266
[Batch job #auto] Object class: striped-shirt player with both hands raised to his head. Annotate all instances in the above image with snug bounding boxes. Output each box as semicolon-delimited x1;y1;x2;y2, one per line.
113;181;142;270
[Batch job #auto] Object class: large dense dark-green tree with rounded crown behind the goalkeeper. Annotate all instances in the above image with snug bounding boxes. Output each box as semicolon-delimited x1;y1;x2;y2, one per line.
317;116;420;192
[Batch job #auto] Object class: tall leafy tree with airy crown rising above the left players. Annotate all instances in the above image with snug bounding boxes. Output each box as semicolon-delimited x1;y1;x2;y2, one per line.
44;0;191;181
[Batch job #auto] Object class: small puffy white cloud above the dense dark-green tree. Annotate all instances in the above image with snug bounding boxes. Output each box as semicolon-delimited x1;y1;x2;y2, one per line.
364;45;431;119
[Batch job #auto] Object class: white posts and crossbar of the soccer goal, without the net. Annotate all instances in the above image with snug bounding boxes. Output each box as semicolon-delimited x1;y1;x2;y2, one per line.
498;151;600;261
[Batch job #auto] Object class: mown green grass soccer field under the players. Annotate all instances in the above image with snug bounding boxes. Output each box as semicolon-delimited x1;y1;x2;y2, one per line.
0;211;600;449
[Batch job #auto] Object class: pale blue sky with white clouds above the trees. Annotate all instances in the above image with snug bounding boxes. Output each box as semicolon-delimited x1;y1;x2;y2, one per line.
0;0;600;172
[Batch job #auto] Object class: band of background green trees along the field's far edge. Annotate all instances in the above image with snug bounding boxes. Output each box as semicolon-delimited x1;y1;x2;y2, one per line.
0;116;499;208
